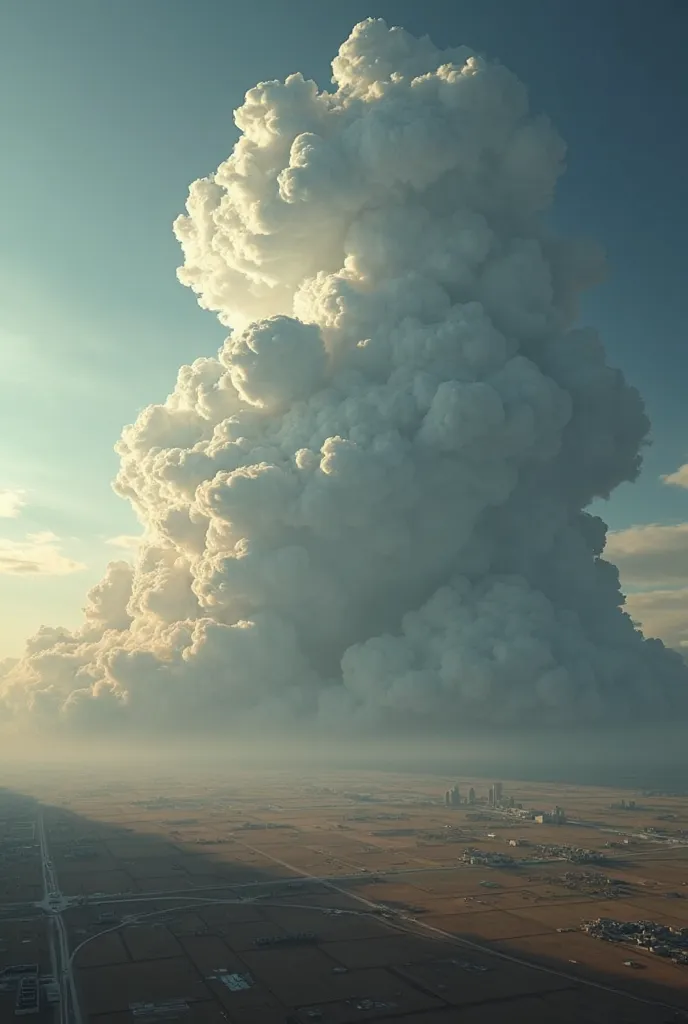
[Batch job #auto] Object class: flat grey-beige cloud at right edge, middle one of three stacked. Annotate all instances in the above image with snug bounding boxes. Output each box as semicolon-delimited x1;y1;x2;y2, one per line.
604;522;688;587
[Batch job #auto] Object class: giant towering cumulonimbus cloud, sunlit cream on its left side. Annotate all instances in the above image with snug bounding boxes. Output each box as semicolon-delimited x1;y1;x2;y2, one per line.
2;20;688;729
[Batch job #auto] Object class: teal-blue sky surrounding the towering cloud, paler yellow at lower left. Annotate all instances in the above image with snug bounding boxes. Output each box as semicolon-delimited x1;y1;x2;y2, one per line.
0;0;688;657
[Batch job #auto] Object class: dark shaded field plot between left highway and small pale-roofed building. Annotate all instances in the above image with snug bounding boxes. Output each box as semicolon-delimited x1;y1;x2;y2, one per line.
78;957;209;1014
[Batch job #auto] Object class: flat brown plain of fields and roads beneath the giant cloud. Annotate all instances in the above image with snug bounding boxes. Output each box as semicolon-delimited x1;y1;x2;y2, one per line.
0;767;688;1024
